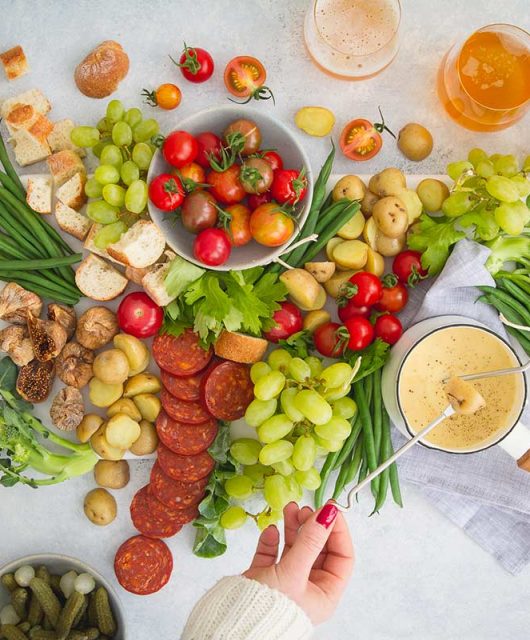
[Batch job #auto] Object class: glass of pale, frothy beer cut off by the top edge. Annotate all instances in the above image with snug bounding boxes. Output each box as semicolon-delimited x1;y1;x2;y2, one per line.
304;0;401;80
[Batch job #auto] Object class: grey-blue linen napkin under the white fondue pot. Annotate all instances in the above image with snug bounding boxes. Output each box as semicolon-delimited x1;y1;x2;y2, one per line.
393;240;530;574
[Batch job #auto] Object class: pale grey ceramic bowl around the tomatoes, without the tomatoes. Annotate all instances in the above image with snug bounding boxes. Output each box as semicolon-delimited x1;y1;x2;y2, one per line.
147;105;313;271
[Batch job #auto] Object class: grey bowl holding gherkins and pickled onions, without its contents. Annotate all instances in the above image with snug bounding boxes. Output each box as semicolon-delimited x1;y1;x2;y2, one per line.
0;553;128;640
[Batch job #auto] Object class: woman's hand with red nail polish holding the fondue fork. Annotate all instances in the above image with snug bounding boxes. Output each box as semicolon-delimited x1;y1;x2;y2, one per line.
243;502;354;624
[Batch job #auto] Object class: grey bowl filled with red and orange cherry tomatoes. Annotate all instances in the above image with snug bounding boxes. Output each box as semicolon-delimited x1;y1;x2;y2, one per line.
147;105;313;271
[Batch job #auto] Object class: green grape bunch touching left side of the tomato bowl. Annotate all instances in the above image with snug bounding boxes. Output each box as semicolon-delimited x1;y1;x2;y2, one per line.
70;100;159;249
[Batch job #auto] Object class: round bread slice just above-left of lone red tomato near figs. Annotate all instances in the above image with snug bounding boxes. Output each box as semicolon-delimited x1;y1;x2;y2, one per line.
75;254;129;302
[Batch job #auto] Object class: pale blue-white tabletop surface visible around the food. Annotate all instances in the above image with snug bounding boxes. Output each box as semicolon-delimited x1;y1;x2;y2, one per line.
0;0;530;640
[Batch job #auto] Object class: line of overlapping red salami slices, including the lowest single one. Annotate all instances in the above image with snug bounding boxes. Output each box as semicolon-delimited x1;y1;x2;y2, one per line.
115;330;253;595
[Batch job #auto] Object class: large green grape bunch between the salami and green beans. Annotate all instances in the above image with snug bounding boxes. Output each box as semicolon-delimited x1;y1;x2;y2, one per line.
220;349;357;529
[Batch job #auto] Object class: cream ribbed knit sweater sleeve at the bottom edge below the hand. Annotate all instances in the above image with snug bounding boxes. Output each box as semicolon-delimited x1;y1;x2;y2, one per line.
181;576;313;640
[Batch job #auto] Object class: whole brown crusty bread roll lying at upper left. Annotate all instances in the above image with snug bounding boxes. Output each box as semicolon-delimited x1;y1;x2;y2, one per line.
74;40;129;98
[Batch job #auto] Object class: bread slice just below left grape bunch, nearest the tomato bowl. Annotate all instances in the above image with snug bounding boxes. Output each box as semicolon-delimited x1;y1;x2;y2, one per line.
107;220;166;269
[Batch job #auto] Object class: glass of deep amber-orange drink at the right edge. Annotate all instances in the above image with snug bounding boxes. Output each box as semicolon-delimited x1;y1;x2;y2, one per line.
438;24;530;131
